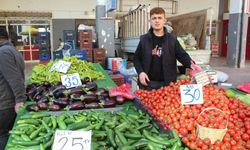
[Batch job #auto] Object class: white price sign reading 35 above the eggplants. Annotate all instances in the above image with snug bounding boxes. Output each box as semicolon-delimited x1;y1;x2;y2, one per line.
61;73;82;89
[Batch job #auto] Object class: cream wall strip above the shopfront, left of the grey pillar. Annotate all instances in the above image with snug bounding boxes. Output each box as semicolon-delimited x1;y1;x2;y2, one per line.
0;0;96;19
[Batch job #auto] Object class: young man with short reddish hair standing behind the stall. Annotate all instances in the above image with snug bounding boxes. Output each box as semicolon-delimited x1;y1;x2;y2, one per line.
134;7;192;90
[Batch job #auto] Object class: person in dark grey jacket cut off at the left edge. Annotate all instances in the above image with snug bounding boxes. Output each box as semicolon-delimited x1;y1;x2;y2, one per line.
0;28;26;150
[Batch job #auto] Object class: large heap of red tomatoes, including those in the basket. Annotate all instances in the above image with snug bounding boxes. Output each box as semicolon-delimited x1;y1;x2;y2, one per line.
135;78;250;150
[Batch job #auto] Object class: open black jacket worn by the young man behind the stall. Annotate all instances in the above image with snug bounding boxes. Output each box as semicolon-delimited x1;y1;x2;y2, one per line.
134;28;192;85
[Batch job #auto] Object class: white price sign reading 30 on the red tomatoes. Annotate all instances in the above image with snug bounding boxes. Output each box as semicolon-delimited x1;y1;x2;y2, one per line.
180;84;203;105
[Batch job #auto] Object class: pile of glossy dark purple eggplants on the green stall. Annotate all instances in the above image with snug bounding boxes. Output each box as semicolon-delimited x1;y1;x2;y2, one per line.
26;78;125;111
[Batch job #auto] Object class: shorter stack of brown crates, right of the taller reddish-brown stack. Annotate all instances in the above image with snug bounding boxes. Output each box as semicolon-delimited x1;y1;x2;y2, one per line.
93;48;106;68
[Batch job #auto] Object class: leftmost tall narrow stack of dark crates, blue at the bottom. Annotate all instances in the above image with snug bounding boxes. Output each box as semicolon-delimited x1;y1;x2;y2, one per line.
38;32;50;61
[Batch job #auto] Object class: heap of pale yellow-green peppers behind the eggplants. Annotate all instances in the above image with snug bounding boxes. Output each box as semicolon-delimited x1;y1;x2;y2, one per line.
29;57;105;83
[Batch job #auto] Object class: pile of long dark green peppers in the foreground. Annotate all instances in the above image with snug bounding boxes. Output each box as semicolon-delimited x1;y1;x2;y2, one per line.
6;105;188;150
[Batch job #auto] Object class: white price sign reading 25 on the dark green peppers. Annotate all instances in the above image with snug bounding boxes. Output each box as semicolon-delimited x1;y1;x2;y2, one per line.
52;130;91;150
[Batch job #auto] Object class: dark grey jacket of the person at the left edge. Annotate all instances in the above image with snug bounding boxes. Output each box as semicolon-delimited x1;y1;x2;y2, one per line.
0;41;26;110
